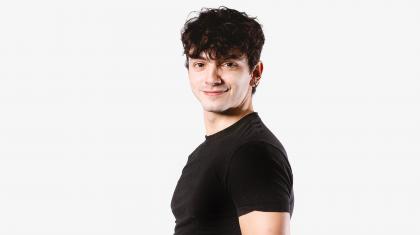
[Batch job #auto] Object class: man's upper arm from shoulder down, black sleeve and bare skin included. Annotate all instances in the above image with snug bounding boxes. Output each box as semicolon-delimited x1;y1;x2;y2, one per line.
226;142;294;235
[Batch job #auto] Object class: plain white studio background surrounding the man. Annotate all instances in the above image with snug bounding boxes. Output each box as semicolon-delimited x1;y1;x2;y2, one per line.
0;0;420;235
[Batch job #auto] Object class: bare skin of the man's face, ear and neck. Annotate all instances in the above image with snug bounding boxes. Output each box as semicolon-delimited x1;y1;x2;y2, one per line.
188;53;263;135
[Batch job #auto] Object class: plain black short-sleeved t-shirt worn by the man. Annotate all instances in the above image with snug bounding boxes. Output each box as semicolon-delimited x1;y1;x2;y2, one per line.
171;112;294;235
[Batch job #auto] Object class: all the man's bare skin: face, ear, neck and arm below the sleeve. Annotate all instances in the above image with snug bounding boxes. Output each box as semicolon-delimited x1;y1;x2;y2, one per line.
188;50;290;235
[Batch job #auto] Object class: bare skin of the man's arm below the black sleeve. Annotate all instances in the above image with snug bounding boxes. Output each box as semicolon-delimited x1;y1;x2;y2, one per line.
239;211;290;235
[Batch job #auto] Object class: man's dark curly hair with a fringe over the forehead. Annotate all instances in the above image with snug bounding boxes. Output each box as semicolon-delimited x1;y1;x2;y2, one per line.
181;6;265;95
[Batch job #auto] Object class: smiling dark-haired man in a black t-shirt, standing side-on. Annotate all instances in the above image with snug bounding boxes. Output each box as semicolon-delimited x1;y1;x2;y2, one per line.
171;7;294;235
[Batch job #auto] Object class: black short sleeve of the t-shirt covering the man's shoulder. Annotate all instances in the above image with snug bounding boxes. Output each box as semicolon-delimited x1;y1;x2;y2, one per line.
226;141;294;216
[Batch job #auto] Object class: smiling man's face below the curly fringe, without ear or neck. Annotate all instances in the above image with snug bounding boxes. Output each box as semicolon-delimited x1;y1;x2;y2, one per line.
188;53;260;113
